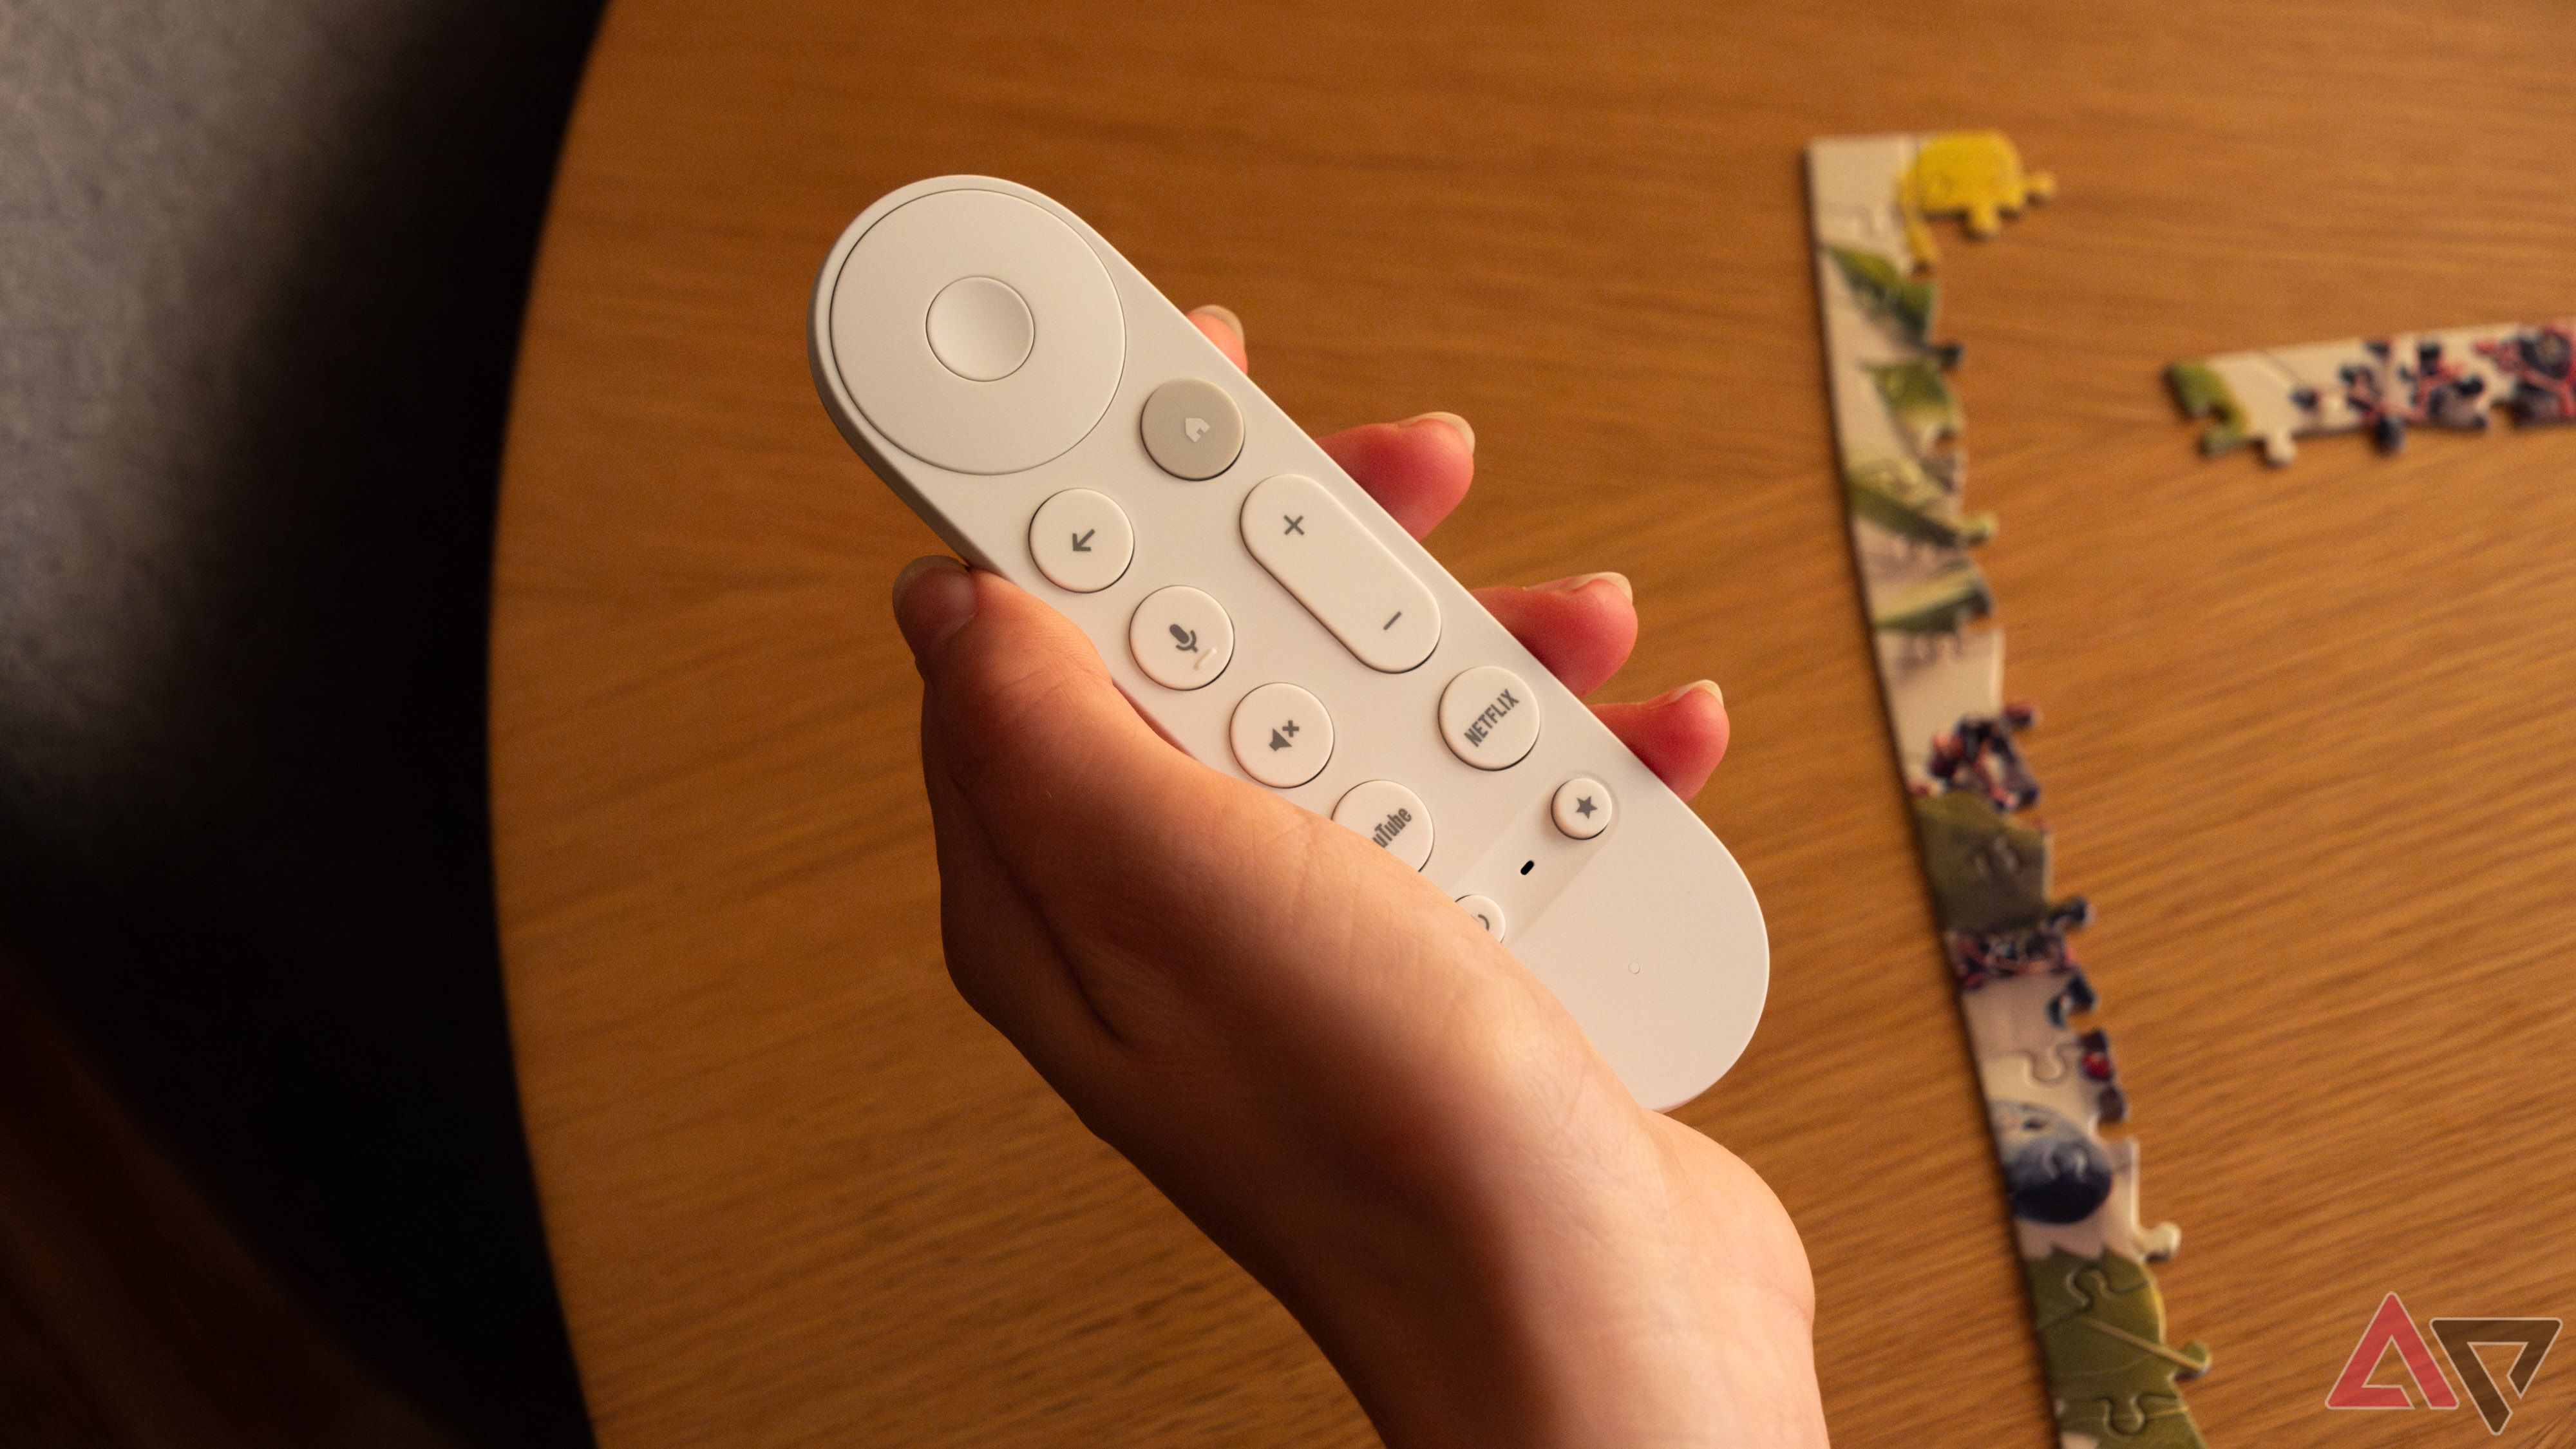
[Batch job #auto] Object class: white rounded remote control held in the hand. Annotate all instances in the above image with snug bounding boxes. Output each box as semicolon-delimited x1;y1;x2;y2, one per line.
811;175;1770;1109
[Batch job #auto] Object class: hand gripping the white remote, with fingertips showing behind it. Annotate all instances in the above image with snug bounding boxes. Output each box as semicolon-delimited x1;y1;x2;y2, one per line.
894;307;1824;1449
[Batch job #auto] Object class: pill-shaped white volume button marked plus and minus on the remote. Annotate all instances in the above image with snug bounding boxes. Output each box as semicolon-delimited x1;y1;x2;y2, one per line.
1244;472;1440;673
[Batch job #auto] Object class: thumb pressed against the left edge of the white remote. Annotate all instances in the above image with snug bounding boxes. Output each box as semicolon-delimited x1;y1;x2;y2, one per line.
894;557;1226;897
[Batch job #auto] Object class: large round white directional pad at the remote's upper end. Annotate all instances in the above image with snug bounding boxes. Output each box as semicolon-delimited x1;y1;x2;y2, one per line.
832;191;1126;475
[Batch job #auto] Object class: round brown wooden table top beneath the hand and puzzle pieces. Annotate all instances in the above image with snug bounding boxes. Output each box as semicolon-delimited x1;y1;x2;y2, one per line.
492;0;2576;1449
